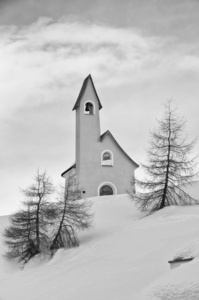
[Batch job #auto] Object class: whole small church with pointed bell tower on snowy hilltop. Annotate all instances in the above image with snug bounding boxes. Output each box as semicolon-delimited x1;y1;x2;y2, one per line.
61;75;138;198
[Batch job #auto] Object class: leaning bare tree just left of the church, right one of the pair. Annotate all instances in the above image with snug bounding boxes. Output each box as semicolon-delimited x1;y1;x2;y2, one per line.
50;176;93;250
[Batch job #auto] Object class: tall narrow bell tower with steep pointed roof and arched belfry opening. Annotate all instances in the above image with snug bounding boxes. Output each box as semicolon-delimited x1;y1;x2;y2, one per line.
73;75;102;192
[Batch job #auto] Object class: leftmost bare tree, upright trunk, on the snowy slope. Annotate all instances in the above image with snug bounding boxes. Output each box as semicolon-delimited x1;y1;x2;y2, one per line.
4;171;54;262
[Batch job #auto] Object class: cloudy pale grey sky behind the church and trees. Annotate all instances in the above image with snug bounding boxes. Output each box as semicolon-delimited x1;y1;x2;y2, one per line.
0;0;199;215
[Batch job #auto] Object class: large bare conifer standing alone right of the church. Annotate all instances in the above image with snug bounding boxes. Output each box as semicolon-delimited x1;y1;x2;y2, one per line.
130;101;198;212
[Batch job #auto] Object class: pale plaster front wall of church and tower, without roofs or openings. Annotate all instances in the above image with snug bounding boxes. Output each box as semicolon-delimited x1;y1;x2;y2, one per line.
72;80;136;197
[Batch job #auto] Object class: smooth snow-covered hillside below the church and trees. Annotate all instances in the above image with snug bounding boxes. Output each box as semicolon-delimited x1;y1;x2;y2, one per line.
0;195;199;300
